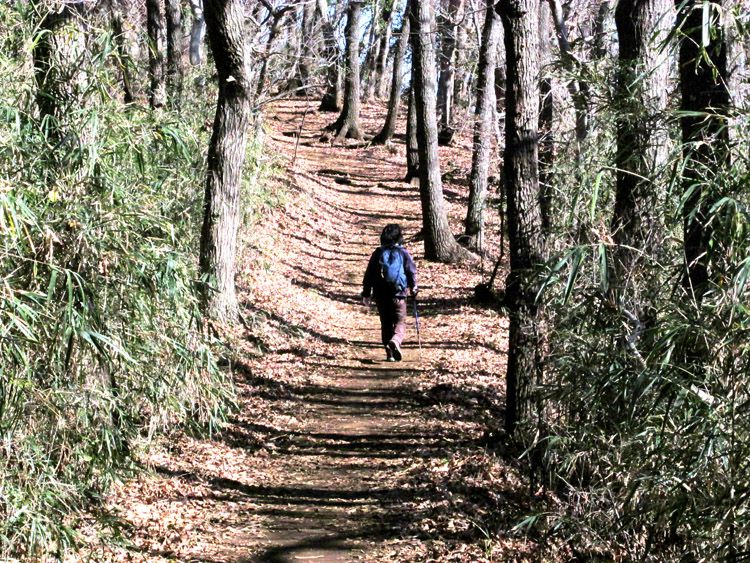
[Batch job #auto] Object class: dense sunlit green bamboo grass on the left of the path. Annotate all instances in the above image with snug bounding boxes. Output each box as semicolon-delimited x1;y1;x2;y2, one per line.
0;7;242;559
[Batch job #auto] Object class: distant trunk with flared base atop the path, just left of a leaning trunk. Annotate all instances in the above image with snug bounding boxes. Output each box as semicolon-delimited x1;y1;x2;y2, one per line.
327;0;363;140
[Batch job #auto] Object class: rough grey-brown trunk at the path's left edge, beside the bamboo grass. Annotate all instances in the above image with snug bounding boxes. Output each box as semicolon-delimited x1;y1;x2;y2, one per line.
200;0;250;322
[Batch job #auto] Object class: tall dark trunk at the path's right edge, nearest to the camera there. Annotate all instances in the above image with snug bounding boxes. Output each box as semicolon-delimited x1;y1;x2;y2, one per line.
498;0;546;433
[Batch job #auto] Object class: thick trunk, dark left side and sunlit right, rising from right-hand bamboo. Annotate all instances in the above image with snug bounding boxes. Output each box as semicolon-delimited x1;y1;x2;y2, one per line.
612;0;674;282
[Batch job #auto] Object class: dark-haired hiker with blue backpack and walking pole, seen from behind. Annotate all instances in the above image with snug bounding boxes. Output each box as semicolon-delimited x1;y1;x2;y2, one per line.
362;223;417;362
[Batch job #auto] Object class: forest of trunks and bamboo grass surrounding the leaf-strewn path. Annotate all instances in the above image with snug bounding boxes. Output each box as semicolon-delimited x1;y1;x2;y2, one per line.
0;0;750;560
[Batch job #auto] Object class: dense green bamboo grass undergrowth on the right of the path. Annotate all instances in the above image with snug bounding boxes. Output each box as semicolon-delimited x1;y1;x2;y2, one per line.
521;51;750;561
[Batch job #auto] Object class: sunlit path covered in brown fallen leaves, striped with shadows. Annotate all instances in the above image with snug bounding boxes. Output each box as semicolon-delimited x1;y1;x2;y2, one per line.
82;100;539;562
